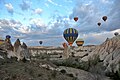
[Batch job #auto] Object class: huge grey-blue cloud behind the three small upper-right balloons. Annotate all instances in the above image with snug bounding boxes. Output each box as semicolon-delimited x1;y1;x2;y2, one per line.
69;0;120;34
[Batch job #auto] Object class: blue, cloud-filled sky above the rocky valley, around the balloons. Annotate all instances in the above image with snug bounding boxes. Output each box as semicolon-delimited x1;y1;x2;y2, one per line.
0;0;120;46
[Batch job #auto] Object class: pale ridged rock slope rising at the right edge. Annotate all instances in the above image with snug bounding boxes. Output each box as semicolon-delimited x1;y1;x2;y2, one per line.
81;35;120;72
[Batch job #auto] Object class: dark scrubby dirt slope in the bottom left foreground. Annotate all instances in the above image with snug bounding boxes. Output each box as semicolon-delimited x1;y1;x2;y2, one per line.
0;52;74;80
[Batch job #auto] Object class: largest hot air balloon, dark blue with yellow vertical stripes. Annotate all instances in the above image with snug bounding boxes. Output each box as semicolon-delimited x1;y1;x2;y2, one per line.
63;28;78;46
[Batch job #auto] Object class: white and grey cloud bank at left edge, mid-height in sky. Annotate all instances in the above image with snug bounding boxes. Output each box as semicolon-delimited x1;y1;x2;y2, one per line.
0;19;30;34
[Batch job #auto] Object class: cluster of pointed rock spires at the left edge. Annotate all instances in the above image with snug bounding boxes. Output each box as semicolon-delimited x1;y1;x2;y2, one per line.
0;39;30;61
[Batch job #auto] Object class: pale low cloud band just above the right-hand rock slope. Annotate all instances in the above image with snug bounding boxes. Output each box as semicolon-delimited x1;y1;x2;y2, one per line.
79;29;120;45
